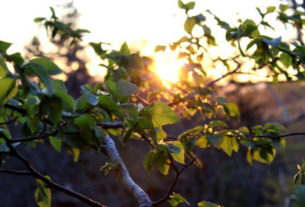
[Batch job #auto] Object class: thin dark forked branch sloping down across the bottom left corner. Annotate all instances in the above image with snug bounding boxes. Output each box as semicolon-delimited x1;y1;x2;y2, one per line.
3;133;105;207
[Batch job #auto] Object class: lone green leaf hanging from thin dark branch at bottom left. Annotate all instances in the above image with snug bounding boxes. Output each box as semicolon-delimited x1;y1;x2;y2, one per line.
34;179;51;207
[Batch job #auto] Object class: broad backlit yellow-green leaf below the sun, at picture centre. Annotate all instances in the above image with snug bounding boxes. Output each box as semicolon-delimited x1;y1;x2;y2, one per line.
144;101;179;127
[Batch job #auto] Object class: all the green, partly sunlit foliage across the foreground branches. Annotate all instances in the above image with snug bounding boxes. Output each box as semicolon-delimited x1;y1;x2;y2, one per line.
0;0;305;207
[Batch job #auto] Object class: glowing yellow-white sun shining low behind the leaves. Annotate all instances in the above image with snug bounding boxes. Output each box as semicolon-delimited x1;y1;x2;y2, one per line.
152;49;185;85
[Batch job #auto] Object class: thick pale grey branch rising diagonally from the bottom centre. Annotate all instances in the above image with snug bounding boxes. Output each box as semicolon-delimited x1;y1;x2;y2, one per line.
102;136;152;207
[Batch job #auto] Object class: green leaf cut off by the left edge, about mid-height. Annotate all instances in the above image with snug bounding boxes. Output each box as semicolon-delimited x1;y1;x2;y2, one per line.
0;78;18;106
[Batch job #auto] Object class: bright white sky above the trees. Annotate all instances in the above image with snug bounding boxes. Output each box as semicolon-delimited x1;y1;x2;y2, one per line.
0;0;280;80
